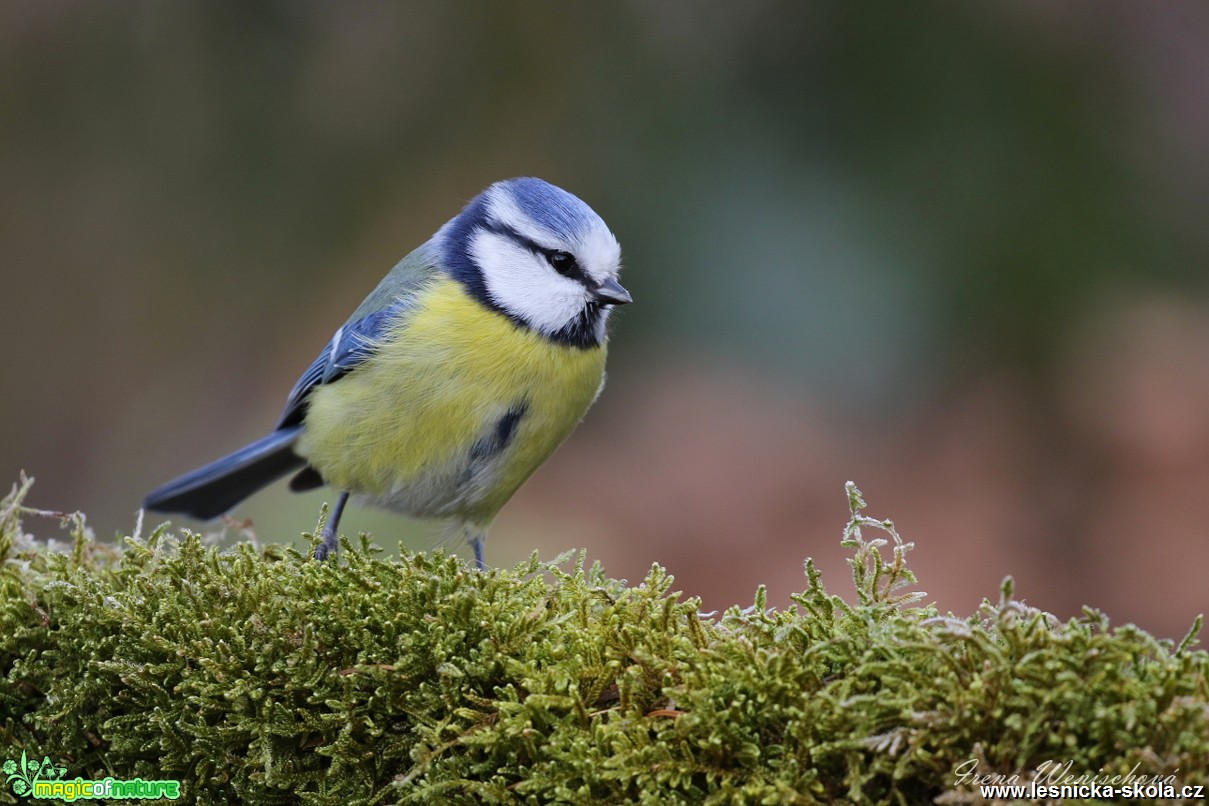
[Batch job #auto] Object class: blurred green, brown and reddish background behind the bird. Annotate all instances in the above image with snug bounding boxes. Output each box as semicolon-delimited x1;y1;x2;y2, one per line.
0;0;1209;638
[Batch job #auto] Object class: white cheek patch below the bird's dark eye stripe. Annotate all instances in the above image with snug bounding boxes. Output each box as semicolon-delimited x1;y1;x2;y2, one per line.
470;232;588;334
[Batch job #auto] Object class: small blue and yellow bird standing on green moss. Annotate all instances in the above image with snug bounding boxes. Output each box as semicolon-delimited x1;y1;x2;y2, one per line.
144;178;631;568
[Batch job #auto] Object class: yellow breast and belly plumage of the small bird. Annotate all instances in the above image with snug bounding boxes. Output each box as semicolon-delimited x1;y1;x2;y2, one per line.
296;278;606;526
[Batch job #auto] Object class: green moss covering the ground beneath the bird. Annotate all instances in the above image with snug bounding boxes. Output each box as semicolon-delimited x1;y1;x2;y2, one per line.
0;483;1209;804
